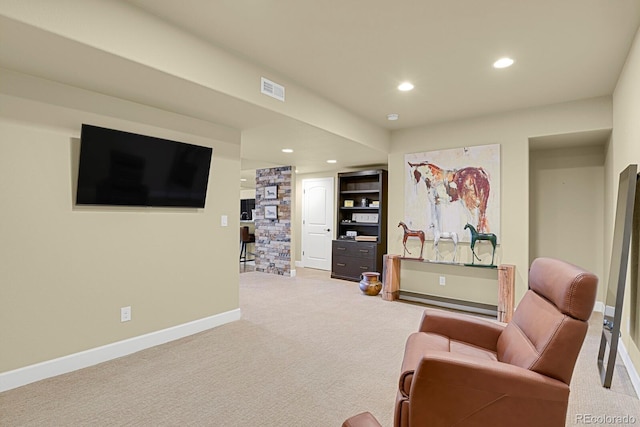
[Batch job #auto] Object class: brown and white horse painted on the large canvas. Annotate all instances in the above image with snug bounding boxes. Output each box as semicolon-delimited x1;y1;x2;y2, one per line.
407;161;491;232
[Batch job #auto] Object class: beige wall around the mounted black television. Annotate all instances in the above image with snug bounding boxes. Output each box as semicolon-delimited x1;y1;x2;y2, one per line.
0;95;240;372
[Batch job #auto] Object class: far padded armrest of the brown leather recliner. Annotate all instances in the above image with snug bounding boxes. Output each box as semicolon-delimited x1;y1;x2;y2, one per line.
419;309;505;352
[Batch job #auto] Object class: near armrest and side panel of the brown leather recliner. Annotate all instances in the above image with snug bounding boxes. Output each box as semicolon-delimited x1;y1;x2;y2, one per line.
409;351;569;426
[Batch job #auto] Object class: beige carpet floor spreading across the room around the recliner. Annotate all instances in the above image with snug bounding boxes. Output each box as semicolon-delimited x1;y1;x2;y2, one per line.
0;269;640;427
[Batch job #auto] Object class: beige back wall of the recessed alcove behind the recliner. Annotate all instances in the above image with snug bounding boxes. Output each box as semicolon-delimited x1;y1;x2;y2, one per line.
529;146;606;292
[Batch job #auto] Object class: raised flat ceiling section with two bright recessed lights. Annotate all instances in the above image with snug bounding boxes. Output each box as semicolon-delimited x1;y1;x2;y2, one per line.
129;0;640;129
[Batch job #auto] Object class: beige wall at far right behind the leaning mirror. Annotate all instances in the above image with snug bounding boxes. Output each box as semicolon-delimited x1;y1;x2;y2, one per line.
605;26;640;382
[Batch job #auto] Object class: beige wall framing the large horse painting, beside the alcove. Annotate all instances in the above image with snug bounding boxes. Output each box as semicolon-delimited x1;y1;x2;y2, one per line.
388;97;612;302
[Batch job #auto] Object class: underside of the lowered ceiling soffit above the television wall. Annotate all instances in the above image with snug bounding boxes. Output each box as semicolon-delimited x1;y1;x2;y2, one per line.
0;9;386;175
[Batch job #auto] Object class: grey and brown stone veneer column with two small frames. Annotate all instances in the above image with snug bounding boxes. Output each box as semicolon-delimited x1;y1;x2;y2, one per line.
254;166;292;276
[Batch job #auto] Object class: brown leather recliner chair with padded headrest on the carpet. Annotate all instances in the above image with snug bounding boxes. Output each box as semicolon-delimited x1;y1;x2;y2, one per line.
343;258;598;427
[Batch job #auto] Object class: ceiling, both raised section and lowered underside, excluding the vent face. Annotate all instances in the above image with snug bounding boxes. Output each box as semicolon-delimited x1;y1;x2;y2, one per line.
0;0;640;189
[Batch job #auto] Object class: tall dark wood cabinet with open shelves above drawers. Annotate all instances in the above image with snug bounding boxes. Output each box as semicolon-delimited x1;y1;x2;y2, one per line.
331;169;387;281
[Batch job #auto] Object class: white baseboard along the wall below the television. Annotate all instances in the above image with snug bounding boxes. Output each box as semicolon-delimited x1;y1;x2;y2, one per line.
0;308;240;392
